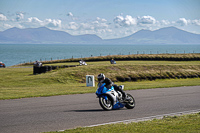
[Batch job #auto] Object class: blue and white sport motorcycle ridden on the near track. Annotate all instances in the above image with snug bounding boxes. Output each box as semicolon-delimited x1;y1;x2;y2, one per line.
96;83;135;110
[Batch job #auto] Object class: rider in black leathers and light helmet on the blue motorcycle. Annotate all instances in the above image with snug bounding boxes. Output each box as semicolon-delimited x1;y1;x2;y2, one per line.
97;73;128;101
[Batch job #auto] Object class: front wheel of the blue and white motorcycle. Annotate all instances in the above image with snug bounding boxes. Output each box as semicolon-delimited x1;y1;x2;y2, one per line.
99;97;113;111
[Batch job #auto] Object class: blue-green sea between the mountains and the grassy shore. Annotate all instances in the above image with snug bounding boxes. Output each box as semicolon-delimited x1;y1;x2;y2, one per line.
0;44;200;67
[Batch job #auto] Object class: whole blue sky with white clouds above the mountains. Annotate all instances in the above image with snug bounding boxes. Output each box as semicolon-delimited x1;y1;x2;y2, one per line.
0;0;200;39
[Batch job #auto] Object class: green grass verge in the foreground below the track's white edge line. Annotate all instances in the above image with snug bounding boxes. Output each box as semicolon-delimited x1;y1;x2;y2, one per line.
49;113;200;133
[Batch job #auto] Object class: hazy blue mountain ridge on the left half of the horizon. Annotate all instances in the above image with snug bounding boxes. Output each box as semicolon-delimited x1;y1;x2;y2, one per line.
0;27;102;44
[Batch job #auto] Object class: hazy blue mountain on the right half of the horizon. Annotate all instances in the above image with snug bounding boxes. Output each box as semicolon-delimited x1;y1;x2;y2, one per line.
104;27;200;44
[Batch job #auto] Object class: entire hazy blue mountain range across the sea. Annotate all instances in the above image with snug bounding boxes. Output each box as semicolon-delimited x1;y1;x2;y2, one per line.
0;27;200;44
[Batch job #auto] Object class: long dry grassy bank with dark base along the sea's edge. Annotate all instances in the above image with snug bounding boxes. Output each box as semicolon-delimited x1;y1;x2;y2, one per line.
21;53;200;65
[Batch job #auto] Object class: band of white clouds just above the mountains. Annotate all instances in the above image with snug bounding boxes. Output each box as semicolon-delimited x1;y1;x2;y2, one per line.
0;12;200;39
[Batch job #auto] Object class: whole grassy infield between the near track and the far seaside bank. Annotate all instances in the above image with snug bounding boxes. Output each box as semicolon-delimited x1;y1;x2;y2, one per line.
0;61;200;99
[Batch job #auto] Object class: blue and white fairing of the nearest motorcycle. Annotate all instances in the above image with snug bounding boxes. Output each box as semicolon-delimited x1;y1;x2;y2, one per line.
96;83;125;109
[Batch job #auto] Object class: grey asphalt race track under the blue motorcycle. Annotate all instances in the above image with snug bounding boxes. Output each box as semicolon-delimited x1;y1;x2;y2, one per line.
0;86;200;133
